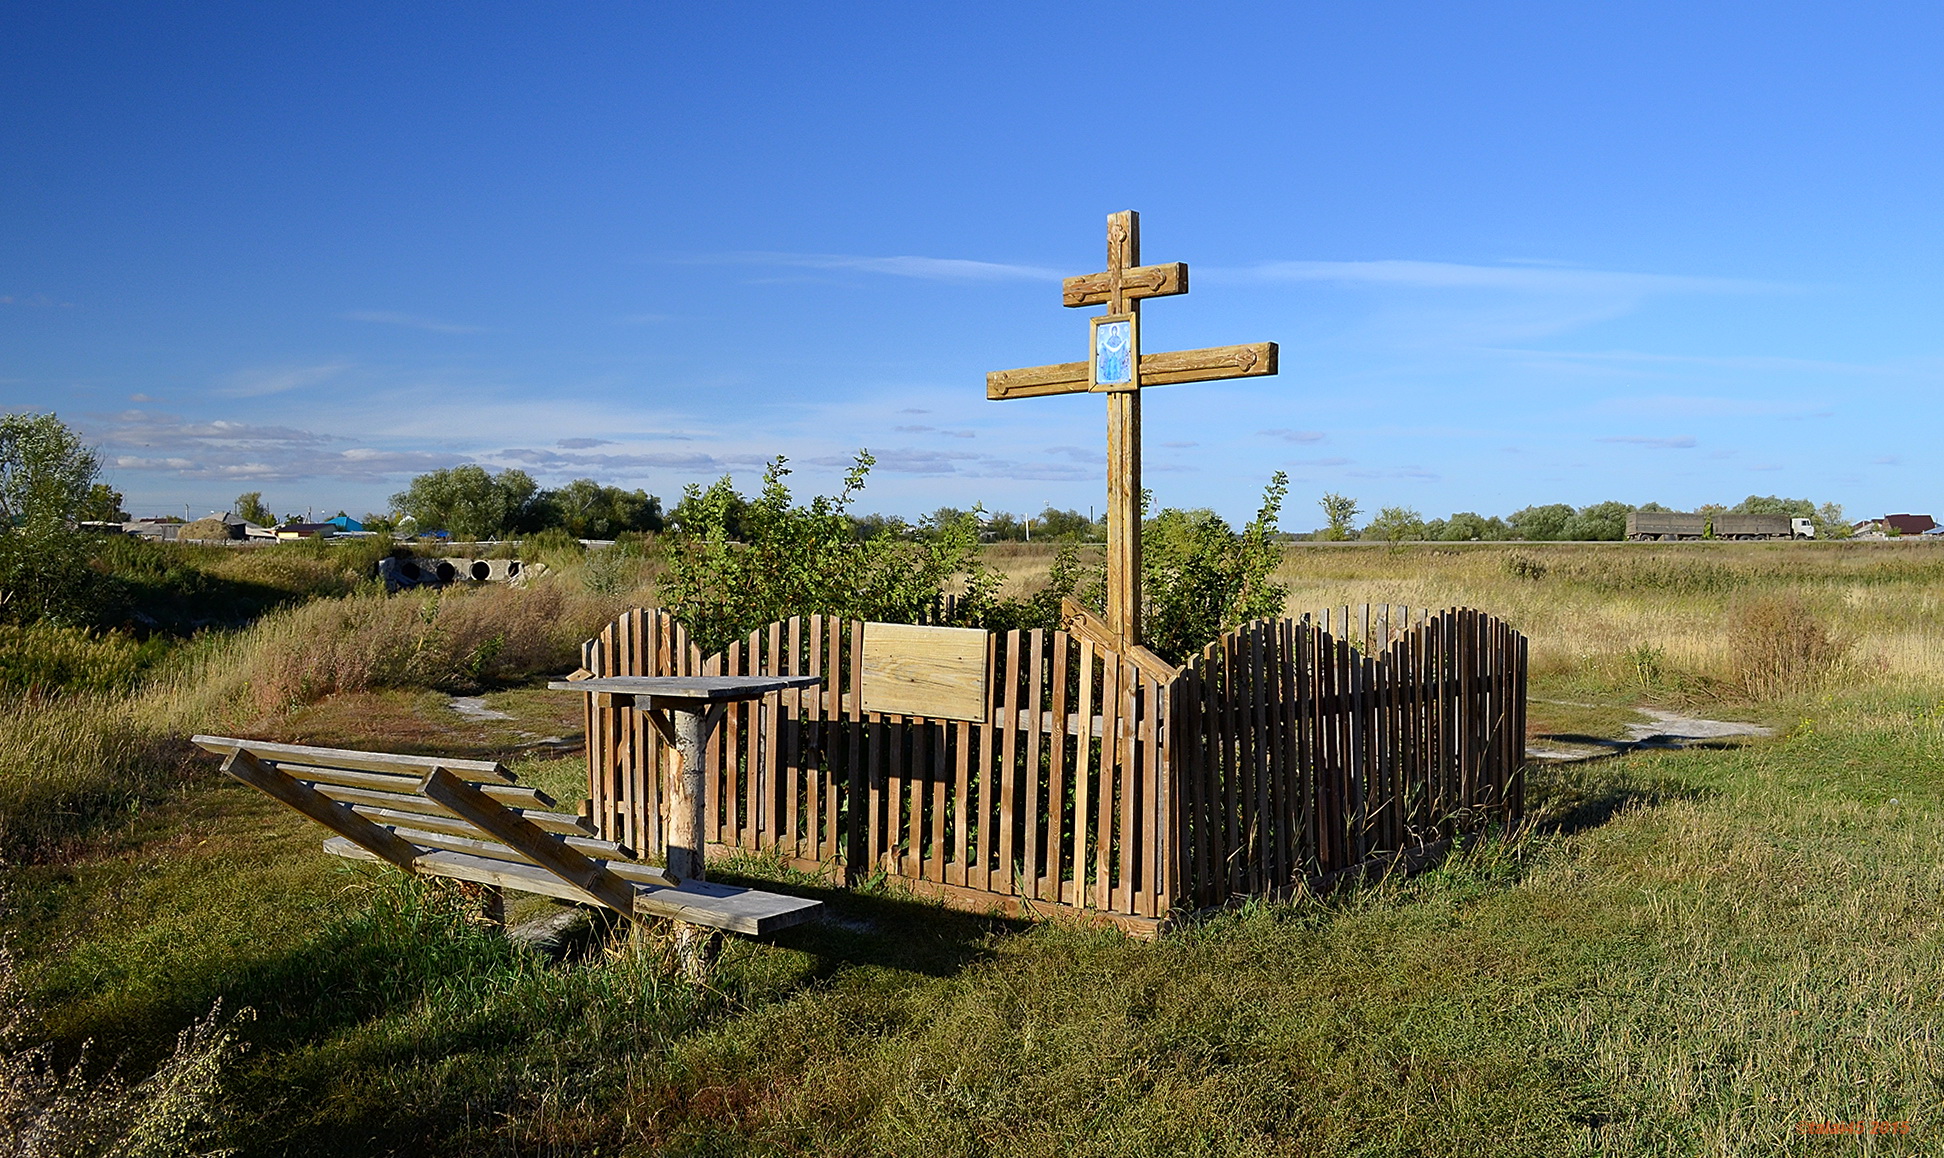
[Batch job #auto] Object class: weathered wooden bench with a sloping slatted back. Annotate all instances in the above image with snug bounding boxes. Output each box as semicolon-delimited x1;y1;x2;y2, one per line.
192;736;824;937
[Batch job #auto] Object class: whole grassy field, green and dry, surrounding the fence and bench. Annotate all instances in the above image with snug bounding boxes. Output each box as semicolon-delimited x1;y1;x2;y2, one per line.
0;544;1944;1156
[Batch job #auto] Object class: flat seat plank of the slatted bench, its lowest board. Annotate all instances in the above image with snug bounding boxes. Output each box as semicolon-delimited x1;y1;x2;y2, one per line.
325;835;824;937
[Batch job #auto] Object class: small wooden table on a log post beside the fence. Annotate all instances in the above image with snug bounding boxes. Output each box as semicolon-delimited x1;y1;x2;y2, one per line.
546;676;824;880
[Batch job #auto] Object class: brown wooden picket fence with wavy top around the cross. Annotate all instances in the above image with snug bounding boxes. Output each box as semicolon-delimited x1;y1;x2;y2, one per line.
567;608;1526;933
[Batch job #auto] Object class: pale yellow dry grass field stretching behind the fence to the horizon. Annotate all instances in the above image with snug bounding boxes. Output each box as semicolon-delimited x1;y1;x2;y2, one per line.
972;542;1944;699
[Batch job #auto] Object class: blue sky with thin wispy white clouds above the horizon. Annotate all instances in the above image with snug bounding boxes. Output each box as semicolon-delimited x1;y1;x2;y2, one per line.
0;2;1944;528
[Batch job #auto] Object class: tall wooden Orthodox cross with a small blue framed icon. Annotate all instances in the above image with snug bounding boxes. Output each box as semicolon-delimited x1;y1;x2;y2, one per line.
986;210;1275;653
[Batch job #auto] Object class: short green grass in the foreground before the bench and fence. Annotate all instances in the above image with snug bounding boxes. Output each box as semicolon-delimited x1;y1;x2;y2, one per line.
14;694;1944;1154
